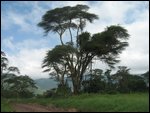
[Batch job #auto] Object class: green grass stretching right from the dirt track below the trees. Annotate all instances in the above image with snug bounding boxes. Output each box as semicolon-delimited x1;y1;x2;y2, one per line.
1;93;149;112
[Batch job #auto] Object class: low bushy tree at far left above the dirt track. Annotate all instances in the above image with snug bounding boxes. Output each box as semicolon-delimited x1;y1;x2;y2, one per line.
2;76;36;98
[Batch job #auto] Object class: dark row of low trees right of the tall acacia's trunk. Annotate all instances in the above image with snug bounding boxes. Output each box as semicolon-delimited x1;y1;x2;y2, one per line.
82;66;148;94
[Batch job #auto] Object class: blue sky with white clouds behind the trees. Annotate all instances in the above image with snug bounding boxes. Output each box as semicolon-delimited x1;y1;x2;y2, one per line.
1;1;149;79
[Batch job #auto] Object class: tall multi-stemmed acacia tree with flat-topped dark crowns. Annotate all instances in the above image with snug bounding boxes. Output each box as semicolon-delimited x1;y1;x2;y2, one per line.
38;5;129;94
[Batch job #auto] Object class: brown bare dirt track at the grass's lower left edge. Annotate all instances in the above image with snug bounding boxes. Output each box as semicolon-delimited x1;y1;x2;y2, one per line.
13;103;77;112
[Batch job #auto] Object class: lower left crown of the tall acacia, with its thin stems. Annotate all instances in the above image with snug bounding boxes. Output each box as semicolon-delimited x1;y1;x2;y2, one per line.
42;45;76;84
